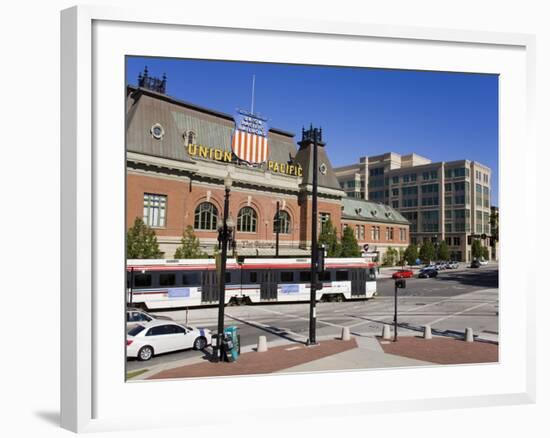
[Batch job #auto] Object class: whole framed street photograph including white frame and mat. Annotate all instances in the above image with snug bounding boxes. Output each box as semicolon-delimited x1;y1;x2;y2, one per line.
61;7;536;432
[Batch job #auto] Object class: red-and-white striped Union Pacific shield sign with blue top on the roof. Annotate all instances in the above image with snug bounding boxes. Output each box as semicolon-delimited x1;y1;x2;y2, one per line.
231;111;269;164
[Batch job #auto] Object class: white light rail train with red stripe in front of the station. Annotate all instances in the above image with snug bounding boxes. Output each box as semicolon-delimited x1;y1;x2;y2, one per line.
126;258;376;309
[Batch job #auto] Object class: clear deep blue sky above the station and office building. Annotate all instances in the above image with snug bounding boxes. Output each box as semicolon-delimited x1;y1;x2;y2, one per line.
126;57;498;205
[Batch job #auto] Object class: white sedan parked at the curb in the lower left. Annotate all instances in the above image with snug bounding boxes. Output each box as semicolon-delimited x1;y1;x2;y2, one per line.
126;320;212;360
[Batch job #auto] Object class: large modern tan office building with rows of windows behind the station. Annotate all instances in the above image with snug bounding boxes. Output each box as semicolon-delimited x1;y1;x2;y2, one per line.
334;152;491;261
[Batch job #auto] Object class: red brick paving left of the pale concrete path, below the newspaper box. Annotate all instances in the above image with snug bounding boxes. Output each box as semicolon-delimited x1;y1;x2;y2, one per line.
149;338;357;379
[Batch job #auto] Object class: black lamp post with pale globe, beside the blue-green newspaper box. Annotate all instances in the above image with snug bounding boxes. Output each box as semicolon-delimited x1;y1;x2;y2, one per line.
214;172;233;362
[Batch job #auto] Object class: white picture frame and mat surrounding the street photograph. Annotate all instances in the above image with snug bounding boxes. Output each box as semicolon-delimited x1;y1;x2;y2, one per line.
61;6;536;432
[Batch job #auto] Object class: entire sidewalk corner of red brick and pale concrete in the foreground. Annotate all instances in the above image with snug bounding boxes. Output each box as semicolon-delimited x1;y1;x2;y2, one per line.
136;335;498;380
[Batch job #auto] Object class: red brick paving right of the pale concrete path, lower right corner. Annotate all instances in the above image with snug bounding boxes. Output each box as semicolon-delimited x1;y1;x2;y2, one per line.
378;336;498;365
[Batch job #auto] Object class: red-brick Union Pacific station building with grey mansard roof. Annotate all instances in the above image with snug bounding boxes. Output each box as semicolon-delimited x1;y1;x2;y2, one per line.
126;70;409;260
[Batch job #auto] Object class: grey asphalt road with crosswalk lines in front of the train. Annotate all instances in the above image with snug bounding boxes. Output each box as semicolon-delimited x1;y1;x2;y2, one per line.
127;266;498;371
